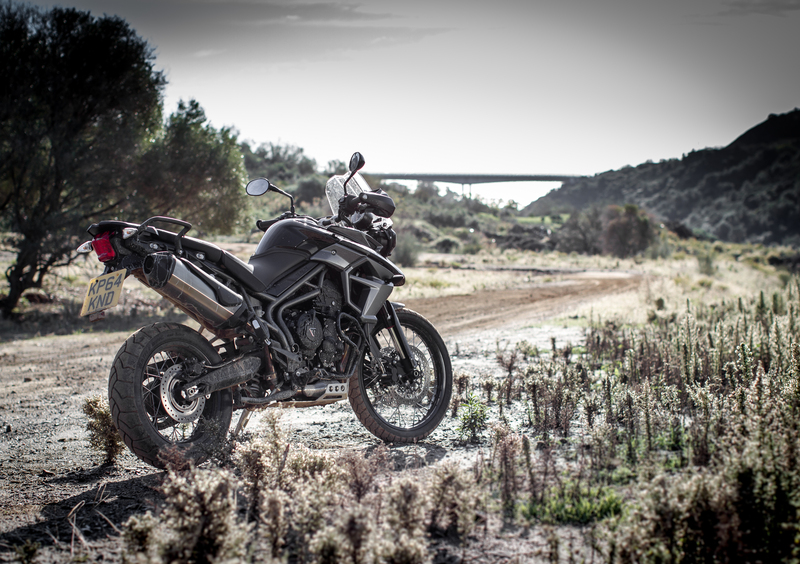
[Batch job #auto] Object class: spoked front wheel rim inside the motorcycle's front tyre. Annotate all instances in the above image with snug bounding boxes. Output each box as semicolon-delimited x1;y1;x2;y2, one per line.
362;327;443;431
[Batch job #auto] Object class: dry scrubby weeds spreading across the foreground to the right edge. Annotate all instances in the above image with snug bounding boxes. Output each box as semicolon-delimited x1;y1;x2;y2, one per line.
111;270;800;563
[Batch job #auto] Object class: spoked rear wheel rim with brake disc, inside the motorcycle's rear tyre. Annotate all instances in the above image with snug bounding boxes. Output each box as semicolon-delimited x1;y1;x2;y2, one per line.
142;348;212;444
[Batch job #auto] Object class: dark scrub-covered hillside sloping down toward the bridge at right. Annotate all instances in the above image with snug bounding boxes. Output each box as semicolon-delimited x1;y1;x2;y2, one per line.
521;109;800;247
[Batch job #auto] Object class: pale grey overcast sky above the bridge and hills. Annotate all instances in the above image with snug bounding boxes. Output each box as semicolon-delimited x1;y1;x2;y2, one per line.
46;0;800;203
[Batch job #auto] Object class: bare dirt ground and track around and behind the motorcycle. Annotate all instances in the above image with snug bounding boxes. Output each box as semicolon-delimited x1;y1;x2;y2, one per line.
0;272;640;562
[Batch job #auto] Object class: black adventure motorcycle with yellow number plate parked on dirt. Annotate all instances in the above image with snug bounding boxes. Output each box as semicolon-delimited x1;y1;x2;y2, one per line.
78;153;453;467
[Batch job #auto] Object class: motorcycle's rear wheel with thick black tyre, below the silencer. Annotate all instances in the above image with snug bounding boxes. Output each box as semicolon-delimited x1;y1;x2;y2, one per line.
108;323;233;468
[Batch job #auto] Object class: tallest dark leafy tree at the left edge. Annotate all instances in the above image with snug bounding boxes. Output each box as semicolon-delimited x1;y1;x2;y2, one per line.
0;2;165;317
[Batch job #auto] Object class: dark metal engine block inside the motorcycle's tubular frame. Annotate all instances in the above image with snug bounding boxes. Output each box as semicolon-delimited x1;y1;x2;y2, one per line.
285;280;344;372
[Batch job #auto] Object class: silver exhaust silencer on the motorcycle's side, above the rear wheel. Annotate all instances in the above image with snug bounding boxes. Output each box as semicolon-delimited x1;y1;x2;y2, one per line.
142;253;245;329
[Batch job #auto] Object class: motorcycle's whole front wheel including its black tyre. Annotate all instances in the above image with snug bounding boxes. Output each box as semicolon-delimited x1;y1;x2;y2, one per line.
349;309;453;443
